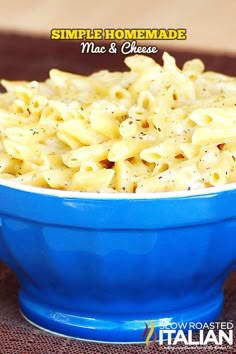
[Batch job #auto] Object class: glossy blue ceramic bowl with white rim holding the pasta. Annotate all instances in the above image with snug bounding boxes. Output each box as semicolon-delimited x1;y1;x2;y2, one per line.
0;181;236;342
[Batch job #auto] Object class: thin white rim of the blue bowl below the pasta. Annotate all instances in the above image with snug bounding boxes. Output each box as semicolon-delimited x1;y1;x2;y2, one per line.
0;178;236;200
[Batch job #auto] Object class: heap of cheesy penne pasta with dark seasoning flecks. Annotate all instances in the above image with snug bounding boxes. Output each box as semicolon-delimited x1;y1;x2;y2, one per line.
0;53;236;193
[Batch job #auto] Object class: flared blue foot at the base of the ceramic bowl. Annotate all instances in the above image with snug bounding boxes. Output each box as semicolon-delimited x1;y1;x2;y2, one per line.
19;290;223;343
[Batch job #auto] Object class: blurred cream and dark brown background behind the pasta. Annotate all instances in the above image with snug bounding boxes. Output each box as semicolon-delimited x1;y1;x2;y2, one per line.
0;0;236;85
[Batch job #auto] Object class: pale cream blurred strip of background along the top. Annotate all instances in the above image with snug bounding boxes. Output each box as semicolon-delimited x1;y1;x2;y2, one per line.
0;0;236;53
